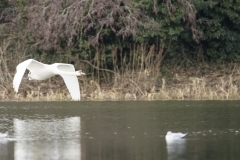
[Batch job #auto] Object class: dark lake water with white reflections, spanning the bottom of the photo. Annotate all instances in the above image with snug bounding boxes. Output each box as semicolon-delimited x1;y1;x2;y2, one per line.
0;101;240;160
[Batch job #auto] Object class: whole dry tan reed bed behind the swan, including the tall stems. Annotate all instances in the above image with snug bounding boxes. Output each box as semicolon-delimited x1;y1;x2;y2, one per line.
0;38;240;101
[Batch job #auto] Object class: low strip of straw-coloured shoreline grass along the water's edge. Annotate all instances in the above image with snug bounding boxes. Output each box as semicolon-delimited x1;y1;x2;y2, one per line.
0;70;240;101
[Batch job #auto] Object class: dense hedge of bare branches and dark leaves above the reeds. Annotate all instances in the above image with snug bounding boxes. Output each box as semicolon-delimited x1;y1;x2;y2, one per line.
0;0;240;74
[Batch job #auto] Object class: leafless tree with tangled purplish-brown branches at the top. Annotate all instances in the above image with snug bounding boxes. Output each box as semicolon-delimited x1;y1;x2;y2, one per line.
26;0;157;49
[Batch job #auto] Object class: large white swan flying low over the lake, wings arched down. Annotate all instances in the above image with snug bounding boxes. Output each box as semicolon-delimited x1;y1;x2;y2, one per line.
13;59;85;101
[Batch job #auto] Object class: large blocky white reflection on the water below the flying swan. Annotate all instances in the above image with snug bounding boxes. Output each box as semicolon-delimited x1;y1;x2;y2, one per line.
13;117;81;160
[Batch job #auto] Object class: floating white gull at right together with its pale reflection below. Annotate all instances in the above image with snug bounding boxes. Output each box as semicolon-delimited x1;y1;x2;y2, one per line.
165;131;186;160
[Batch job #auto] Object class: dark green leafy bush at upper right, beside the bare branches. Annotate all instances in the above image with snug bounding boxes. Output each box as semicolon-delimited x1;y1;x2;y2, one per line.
132;0;240;62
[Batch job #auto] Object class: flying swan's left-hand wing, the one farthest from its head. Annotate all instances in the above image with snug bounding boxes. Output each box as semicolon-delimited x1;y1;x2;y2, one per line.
13;59;34;92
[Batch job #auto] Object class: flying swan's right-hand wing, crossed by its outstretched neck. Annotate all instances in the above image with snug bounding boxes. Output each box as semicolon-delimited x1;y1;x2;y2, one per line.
57;64;80;101
